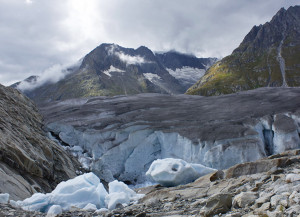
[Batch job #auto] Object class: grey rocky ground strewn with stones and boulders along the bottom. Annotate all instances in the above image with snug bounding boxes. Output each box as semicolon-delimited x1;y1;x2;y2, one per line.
0;150;300;217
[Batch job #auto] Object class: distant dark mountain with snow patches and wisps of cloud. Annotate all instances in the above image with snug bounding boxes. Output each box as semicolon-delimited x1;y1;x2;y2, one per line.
14;44;215;102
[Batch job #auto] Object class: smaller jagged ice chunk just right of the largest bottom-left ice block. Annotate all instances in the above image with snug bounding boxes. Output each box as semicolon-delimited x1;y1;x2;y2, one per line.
105;180;144;210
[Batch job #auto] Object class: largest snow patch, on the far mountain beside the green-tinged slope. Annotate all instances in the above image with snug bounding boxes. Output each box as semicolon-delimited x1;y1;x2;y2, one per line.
167;66;206;83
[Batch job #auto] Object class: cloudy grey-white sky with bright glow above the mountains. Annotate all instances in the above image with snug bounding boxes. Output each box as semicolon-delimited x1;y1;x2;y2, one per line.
0;0;300;85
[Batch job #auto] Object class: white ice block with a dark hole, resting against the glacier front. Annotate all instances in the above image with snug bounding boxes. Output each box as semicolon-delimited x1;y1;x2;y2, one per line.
146;158;216;187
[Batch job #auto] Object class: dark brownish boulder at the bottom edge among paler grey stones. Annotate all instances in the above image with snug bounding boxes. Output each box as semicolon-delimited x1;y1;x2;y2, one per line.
202;194;232;216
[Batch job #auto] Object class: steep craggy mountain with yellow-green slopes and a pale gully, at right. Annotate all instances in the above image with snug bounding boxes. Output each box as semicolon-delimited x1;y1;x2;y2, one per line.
187;6;300;96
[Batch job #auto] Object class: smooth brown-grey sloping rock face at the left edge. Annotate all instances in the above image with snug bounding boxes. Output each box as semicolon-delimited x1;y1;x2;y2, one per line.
0;85;78;200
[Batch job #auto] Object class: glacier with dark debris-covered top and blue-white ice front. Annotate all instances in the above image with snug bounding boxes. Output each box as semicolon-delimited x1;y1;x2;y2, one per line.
41;88;300;186
